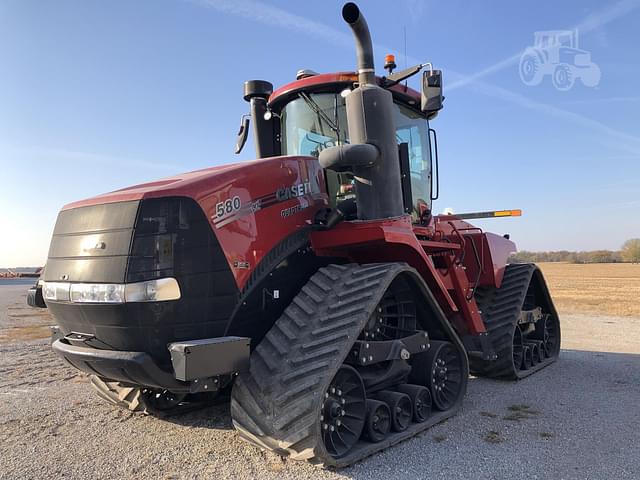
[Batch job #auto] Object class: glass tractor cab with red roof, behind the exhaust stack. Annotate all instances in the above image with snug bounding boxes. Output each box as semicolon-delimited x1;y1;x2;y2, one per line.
238;67;442;223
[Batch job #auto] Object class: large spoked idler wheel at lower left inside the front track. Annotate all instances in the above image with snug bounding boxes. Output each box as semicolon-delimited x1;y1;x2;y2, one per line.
320;365;366;457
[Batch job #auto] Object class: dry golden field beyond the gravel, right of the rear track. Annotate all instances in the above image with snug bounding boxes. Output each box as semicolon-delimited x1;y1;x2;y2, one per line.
538;262;640;317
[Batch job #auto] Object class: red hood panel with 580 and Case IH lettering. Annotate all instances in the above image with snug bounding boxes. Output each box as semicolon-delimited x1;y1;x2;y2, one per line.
64;157;328;289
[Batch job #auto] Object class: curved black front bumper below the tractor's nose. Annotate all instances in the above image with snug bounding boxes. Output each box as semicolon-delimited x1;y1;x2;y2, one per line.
51;339;190;392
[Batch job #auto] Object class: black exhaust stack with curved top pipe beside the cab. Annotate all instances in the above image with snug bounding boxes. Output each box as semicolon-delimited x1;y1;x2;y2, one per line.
319;3;404;220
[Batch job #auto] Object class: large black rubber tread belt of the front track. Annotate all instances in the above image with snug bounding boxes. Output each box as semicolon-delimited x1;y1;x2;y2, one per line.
231;263;464;466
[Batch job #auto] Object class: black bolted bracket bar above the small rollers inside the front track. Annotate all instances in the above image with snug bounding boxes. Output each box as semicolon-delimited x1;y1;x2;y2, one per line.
345;332;430;365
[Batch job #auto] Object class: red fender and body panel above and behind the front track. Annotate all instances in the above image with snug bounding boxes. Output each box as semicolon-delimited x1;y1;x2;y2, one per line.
311;216;515;335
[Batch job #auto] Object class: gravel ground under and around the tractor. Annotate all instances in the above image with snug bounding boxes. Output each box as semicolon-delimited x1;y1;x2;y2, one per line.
0;285;640;480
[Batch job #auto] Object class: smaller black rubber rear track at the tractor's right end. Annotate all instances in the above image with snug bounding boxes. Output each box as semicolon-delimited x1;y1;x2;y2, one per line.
469;263;558;380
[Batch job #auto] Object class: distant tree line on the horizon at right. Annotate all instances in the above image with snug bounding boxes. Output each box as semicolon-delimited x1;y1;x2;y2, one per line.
509;238;640;263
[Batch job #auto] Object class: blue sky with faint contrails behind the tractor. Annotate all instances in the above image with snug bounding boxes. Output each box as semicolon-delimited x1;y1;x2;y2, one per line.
0;0;640;266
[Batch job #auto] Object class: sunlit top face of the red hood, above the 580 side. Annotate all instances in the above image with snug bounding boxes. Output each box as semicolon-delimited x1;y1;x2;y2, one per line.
62;157;291;210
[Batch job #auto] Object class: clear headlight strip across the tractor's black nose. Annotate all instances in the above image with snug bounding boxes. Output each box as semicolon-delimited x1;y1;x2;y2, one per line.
42;278;180;304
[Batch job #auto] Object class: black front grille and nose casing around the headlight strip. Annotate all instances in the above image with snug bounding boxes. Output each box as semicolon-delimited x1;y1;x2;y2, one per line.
46;197;239;365
